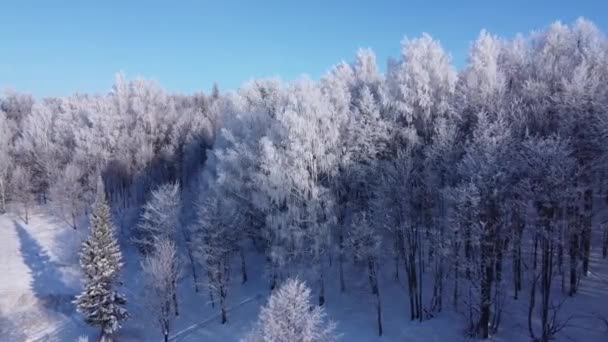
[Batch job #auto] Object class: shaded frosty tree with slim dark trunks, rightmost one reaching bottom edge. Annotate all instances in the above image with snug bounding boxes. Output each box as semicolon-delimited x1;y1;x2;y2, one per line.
521;136;575;342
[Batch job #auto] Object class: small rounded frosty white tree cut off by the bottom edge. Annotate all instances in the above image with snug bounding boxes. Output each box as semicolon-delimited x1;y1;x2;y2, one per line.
242;279;338;342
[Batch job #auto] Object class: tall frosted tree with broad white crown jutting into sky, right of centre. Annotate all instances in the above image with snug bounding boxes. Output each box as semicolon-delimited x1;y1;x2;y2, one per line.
386;34;456;319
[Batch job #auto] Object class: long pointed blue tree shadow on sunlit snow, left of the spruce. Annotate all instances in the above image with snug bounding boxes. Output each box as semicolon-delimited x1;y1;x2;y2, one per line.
13;221;74;315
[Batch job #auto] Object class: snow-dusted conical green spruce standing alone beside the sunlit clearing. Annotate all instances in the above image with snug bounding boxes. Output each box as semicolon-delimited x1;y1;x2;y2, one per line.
75;181;128;341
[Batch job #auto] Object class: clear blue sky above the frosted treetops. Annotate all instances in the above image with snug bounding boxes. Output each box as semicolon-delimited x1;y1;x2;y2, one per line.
0;0;608;96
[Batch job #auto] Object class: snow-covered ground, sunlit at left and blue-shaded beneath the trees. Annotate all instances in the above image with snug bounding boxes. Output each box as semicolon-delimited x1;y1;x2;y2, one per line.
0;207;608;342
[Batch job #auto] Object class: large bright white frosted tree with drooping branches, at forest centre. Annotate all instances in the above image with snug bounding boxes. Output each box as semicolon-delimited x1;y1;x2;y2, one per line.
256;80;339;305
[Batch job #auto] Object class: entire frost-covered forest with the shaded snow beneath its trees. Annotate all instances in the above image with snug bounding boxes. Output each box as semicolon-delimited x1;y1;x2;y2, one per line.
0;19;608;342
